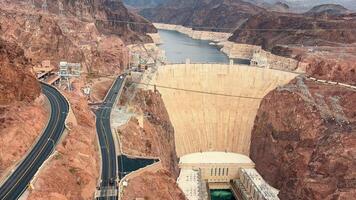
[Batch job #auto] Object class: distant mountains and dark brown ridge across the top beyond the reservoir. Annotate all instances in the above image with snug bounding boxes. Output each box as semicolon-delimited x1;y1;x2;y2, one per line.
140;0;356;51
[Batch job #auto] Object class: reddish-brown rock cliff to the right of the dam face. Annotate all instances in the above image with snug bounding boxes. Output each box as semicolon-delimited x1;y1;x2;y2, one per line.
250;77;356;200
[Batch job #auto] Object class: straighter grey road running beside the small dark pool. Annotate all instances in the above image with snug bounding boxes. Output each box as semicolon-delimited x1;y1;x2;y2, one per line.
95;75;125;200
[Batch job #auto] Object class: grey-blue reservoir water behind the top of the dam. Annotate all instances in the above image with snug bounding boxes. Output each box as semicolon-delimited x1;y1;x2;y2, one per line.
158;30;229;63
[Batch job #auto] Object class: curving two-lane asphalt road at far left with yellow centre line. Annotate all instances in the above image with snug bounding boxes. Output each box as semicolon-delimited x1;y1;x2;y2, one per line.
0;83;69;200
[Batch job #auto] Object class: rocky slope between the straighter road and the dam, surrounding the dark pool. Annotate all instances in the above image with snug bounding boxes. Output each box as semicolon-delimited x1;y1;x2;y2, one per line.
118;80;185;200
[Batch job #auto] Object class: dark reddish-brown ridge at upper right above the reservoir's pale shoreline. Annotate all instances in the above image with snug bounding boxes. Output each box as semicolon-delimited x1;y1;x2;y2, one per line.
229;12;356;50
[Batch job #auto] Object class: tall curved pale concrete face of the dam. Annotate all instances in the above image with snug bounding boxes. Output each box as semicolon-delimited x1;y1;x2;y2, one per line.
150;64;298;157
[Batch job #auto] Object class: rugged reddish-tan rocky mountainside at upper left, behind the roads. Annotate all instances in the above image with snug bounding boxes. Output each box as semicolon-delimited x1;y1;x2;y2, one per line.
0;1;155;73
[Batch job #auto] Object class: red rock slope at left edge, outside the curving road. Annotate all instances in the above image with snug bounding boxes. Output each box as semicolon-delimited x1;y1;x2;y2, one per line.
0;39;49;179
